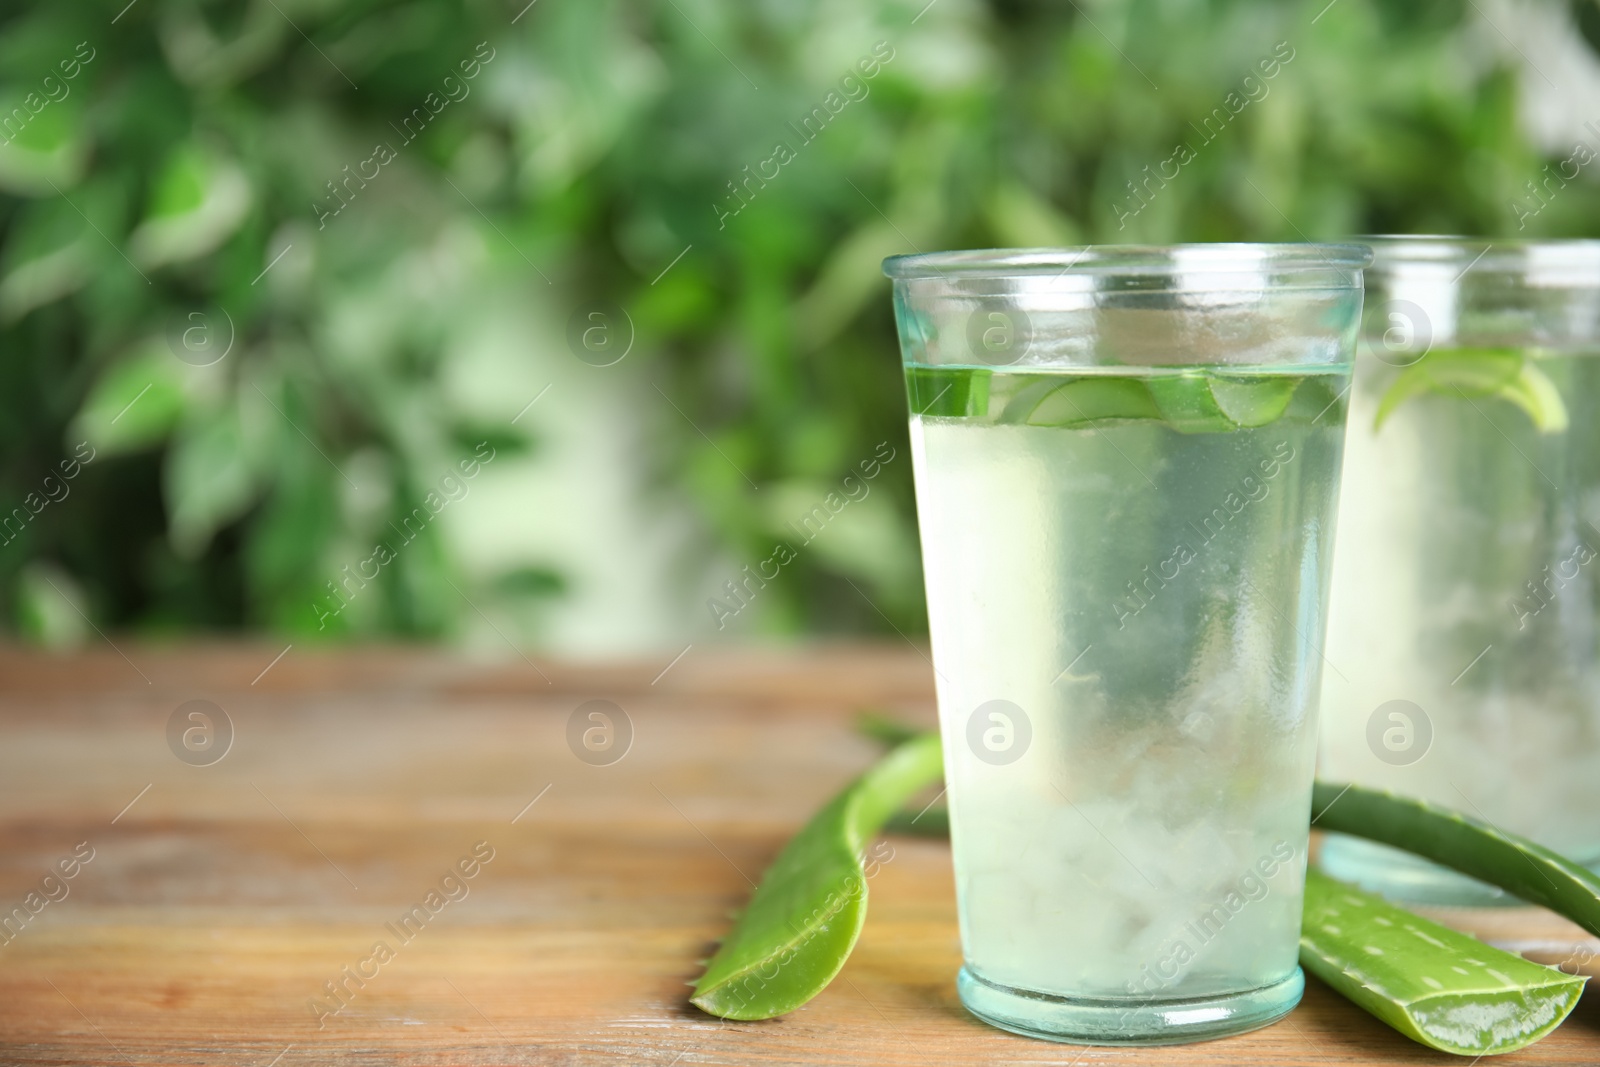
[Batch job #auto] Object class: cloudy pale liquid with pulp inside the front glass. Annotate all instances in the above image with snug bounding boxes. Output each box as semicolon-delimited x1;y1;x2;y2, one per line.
912;371;1344;998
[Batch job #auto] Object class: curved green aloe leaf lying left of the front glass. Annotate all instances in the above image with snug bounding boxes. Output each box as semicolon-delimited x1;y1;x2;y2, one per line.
690;734;944;1019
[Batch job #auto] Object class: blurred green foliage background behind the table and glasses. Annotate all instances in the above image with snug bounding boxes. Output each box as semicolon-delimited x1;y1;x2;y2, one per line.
0;0;1600;656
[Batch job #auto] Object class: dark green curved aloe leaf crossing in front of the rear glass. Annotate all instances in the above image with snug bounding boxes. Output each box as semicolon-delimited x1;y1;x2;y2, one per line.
1310;782;1600;934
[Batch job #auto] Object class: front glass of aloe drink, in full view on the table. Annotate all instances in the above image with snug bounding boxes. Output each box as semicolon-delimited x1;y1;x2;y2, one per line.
885;245;1368;1045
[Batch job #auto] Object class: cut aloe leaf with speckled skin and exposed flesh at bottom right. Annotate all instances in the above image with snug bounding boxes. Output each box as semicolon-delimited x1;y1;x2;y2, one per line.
1301;870;1587;1056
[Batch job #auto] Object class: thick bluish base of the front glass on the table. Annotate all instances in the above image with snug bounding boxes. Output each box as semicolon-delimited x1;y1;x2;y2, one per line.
955;966;1306;1045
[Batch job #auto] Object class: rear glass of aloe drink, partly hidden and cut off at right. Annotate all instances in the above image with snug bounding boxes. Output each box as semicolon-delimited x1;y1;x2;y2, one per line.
1320;237;1600;904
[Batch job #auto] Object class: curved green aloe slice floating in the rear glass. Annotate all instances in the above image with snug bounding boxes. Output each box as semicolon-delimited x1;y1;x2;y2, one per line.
1373;349;1566;434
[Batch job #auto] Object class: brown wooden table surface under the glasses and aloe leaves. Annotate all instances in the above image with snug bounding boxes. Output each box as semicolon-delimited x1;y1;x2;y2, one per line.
0;640;1600;1067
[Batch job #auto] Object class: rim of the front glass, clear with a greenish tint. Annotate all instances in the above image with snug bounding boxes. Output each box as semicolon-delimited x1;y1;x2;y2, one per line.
883;242;1369;279
